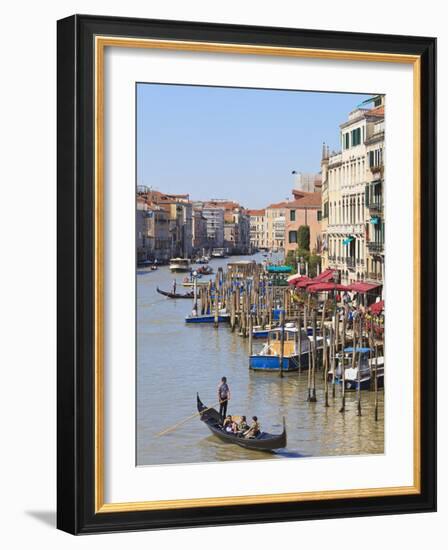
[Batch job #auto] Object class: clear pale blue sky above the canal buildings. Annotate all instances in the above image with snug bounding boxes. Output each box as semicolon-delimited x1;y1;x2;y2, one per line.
137;84;369;208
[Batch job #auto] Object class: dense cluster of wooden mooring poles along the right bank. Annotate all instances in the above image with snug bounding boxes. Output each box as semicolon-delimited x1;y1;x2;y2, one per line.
195;264;382;420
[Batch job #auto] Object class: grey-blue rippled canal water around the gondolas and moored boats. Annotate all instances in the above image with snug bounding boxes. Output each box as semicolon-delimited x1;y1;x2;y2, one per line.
136;255;384;465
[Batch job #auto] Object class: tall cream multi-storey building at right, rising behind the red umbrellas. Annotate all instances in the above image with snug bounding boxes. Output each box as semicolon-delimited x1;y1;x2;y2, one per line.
321;96;384;284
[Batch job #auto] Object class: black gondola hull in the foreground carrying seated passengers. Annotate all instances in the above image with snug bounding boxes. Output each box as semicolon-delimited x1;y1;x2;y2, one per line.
197;394;286;451
